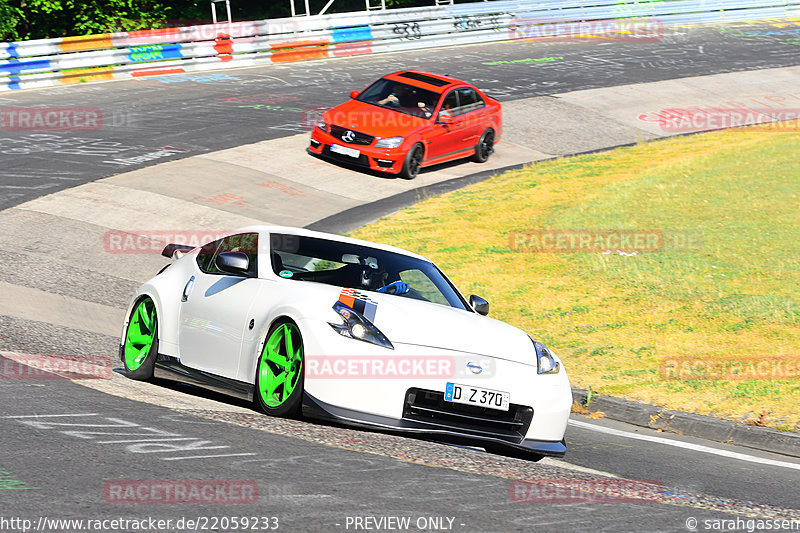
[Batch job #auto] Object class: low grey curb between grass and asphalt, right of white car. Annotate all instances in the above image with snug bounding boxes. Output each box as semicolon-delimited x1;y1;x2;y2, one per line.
572;387;800;457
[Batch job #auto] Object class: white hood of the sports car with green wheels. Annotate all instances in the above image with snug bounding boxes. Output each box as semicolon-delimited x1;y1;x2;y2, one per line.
288;282;536;365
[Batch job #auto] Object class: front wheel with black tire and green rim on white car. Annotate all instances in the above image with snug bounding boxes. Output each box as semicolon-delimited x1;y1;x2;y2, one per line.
254;320;305;418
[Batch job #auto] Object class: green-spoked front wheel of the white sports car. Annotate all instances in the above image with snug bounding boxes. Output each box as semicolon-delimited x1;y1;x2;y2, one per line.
255;321;304;416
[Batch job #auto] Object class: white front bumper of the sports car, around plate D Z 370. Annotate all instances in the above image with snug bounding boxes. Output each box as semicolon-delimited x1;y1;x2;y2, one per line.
299;320;572;455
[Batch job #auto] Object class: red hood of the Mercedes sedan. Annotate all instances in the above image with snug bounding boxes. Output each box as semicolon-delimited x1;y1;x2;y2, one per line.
324;100;428;138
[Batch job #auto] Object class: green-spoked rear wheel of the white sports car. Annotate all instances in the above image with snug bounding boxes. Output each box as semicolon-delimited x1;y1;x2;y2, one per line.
122;297;158;381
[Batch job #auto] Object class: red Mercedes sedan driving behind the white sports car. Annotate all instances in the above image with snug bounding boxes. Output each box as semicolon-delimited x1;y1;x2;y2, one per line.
308;70;502;179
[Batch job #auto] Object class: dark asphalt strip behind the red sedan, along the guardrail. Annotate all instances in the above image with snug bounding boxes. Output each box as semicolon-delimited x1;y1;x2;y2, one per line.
0;24;800;209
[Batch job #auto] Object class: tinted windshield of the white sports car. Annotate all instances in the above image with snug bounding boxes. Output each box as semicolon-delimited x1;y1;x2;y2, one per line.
270;234;468;310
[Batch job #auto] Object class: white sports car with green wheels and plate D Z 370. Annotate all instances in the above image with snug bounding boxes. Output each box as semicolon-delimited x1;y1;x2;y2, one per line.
120;226;572;459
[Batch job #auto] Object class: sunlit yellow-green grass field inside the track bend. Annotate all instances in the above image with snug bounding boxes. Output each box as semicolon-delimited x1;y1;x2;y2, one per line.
353;130;800;431
